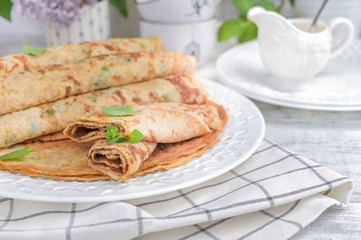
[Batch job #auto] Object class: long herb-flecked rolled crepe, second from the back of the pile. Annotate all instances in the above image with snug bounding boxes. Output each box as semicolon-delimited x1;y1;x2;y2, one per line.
0;52;195;114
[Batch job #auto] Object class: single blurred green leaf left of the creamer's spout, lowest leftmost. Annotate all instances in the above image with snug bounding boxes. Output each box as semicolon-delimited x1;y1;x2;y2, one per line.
218;19;245;41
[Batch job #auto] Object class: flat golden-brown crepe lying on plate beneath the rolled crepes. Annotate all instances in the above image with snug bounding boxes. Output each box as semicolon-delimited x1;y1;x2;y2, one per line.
0;132;218;181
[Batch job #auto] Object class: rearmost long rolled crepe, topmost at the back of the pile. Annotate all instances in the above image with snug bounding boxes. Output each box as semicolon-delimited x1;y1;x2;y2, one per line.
0;37;164;75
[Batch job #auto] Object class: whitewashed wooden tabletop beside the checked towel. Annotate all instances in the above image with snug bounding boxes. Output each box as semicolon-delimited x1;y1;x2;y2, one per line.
197;57;361;240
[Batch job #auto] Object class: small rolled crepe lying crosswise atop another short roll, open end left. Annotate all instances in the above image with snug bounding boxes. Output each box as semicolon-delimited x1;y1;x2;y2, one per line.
64;102;222;143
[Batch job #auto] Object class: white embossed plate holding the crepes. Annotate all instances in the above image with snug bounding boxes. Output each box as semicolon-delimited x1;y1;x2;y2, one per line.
0;79;265;202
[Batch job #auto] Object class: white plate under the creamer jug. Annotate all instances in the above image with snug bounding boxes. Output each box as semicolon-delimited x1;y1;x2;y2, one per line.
216;41;361;111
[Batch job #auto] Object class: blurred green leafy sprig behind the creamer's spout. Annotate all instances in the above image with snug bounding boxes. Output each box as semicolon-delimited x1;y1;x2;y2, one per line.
218;0;295;43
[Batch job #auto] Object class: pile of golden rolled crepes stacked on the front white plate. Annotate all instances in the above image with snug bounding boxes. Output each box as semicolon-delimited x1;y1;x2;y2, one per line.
0;37;227;182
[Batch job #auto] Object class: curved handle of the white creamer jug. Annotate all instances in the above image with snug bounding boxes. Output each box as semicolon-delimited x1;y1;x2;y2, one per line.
328;17;355;58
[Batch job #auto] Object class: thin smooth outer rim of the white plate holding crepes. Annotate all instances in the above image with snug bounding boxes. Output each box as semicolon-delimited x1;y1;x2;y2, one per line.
0;77;265;203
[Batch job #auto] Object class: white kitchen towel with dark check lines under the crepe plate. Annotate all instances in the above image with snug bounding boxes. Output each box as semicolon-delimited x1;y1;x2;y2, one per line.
0;140;353;240
